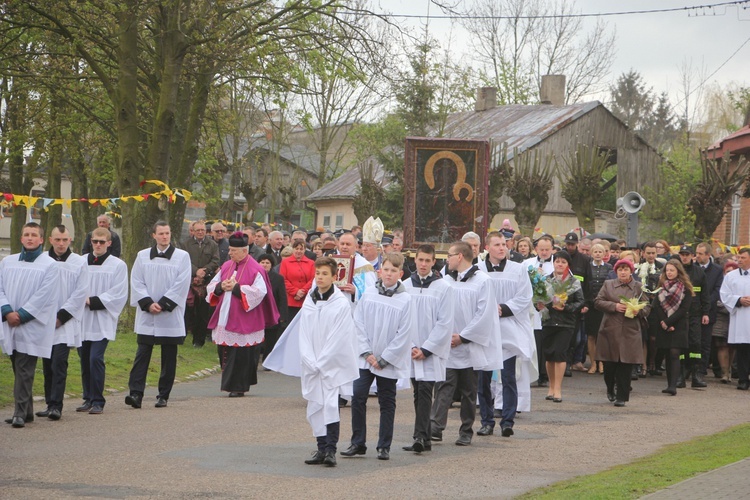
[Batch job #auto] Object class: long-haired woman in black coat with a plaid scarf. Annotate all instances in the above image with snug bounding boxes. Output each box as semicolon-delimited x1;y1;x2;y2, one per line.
649;259;695;396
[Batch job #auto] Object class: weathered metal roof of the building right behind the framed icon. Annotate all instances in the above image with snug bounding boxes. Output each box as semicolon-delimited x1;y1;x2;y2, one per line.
443;101;602;158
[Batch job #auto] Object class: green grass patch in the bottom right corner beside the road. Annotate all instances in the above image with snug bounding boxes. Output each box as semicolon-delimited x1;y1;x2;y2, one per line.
520;424;750;499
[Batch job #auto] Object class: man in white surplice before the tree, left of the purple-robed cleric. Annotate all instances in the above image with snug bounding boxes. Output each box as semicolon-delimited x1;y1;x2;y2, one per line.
125;221;191;408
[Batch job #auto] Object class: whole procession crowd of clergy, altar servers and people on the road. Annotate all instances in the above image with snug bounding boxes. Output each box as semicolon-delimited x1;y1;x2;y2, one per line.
0;217;750;466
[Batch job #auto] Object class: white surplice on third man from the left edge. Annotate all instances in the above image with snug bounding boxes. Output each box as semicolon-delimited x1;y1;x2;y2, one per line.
81;254;128;342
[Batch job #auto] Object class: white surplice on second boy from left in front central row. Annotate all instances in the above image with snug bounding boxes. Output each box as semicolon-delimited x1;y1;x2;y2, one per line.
354;283;416;379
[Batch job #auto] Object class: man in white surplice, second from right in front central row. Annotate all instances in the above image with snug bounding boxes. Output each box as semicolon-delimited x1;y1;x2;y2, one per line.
431;241;503;446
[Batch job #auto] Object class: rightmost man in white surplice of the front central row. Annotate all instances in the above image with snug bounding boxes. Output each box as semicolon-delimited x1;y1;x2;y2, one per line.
477;232;535;437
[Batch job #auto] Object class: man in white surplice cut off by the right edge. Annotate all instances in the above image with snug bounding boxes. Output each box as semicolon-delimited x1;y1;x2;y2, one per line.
720;247;750;391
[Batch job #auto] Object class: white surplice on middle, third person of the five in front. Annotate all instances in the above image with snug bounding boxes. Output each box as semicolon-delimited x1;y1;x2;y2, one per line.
404;274;453;382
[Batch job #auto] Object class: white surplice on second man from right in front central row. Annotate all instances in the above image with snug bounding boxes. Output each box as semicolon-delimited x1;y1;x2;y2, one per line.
444;270;503;371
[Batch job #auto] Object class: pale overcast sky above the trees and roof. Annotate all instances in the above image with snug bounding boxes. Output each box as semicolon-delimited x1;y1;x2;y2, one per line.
373;0;750;104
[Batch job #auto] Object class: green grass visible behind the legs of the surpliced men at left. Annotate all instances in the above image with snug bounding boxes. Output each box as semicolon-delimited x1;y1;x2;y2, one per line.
0;331;219;407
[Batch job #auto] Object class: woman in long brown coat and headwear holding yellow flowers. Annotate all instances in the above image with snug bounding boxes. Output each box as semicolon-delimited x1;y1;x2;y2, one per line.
594;259;651;406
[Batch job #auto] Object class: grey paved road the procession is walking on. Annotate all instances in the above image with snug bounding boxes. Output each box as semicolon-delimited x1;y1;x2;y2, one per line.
0;372;750;498
